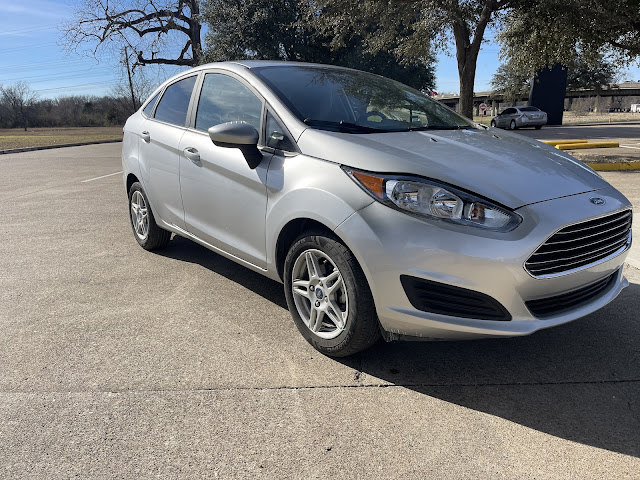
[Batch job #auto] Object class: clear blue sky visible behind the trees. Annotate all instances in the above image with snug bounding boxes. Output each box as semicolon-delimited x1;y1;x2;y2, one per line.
0;0;640;98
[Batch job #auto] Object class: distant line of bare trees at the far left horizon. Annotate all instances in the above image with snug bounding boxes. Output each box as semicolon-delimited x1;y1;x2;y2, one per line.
0;90;134;129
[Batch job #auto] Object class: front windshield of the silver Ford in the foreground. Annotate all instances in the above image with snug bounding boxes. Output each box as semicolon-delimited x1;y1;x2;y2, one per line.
252;65;478;133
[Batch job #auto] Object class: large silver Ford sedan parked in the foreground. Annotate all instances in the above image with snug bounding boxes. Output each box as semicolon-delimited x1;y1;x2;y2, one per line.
122;61;632;356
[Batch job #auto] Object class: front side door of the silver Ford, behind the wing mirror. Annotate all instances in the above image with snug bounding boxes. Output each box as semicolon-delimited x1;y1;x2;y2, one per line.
180;72;272;268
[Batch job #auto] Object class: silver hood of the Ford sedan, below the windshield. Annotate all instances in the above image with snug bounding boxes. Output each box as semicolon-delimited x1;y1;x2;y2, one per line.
298;128;608;209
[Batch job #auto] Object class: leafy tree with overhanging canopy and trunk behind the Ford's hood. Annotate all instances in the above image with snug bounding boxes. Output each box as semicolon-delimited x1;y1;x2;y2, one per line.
311;0;640;117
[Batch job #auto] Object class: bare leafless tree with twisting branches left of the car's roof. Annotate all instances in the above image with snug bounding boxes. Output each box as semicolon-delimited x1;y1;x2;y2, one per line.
62;0;202;67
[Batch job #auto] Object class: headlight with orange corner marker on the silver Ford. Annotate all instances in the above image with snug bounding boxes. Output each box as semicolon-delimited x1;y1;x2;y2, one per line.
343;167;522;232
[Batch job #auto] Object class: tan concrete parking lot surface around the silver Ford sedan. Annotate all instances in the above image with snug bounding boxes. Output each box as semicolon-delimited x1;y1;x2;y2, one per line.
0;144;640;479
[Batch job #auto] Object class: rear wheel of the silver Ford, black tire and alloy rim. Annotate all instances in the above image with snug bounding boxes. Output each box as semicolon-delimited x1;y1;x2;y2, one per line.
129;182;171;250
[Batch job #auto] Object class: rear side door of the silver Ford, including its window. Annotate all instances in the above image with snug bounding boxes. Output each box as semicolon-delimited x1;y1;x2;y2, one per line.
138;75;197;228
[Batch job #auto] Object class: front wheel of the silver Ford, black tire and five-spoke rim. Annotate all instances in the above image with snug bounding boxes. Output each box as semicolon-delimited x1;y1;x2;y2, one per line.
284;232;380;357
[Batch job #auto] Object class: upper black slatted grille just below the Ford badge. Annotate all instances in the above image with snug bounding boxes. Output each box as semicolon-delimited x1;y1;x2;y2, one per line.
524;210;632;277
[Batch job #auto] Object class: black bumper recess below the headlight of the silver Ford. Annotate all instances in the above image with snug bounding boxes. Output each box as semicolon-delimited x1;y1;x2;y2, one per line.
400;275;511;321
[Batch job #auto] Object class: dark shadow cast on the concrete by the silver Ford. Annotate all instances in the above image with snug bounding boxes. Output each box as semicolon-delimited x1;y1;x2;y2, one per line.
159;237;640;457
